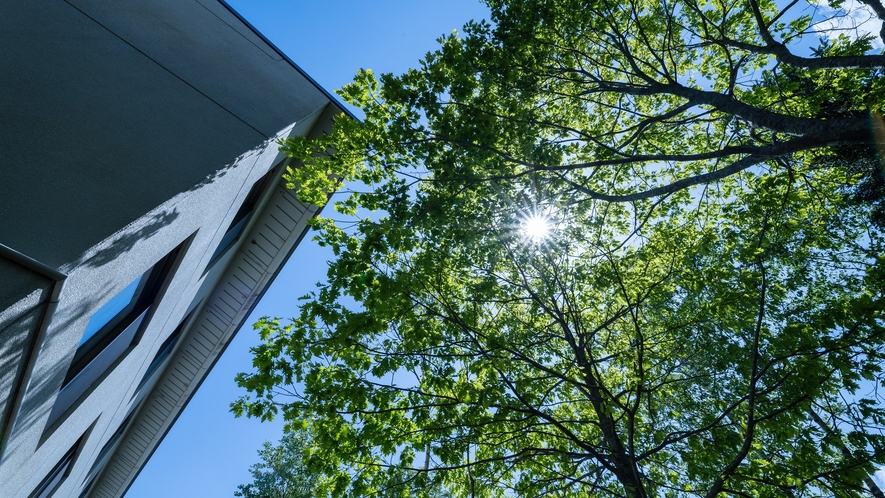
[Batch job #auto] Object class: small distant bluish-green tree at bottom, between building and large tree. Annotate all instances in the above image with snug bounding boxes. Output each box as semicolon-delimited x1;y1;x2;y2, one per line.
234;432;316;498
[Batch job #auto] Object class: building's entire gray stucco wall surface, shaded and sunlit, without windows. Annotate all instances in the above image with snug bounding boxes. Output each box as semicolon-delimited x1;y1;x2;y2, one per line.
0;0;340;496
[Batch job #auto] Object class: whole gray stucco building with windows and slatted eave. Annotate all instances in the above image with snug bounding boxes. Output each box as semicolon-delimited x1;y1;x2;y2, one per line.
0;0;342;497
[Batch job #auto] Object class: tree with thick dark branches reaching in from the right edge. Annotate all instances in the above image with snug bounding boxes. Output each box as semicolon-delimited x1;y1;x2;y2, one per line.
287;0;885;210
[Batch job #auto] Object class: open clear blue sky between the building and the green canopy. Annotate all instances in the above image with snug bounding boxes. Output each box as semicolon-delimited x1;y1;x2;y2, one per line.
126;0;487;498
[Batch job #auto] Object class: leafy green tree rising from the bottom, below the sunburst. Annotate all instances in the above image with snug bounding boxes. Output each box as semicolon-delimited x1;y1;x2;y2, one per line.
238;175;885;496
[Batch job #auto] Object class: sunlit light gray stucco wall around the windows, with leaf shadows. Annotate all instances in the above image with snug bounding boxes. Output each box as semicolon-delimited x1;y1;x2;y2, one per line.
0;125;310;497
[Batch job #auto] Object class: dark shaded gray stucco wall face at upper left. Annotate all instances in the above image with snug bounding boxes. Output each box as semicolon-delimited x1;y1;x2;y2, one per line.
0;0;327;267
